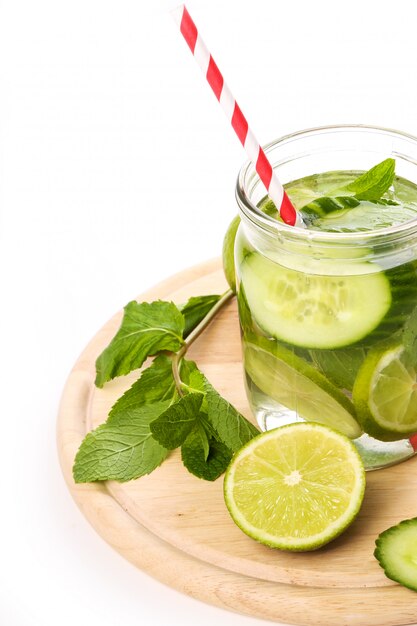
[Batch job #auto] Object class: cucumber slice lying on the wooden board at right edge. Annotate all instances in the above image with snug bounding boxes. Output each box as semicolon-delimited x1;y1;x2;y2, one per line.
374;517;417;591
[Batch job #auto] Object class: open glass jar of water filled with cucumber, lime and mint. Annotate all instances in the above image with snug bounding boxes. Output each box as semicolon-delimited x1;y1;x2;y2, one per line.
235;127;417;469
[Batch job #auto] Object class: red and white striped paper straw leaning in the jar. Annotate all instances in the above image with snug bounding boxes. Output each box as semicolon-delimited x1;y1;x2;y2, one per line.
171;4;303;226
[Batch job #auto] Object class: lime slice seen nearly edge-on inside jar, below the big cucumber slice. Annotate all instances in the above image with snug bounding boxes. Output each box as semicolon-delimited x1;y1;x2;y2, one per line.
244;337;362;439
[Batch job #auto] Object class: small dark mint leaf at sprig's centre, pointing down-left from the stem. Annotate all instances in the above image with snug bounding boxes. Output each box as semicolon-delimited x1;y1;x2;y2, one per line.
150;393;203;450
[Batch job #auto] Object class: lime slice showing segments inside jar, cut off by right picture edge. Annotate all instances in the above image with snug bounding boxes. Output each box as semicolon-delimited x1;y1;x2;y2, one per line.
353;344;417;441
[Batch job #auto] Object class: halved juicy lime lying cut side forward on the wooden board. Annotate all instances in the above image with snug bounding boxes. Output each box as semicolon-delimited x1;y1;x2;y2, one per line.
224;422;365;551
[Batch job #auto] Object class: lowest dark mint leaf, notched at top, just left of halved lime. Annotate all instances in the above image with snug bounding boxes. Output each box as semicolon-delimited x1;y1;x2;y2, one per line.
181;429;233;481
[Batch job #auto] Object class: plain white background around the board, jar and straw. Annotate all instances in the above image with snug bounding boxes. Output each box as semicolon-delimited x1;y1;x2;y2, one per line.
0;0;417;626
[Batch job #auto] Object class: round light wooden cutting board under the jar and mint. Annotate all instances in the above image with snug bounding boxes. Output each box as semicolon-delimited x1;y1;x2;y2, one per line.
58;260;417;626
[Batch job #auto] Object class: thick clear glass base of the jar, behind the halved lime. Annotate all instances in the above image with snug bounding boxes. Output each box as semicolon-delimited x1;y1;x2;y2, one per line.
254;407;416;472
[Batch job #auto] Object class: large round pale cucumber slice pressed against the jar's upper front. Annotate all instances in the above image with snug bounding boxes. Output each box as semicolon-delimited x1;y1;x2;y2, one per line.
241;253;391;349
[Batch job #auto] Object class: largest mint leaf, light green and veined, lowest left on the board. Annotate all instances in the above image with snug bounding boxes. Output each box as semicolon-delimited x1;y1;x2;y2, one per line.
73;402;169;483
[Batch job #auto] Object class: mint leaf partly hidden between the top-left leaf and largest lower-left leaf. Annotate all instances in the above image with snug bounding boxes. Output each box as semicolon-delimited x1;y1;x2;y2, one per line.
109;354;176;420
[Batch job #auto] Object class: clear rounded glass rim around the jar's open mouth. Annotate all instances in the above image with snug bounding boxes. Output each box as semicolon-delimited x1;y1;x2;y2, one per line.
235;124;417;245
